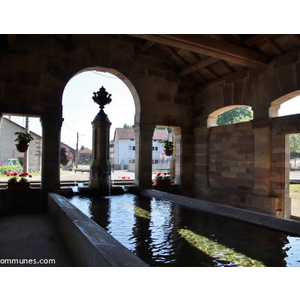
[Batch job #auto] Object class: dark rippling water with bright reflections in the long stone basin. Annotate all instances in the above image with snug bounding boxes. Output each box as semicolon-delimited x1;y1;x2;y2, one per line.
69;194;300;267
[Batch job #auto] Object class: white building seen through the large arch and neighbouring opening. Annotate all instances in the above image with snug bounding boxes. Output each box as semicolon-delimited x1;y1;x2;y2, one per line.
113;128;169;170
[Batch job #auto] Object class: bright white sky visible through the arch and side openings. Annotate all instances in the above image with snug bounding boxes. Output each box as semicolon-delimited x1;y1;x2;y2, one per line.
4;71;300;149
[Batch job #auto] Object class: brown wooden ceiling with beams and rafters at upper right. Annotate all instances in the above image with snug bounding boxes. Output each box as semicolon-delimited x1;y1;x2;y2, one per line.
127;34;300;85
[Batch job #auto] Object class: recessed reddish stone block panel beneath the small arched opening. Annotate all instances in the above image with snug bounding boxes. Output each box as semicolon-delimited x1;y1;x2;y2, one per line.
208;122;254;192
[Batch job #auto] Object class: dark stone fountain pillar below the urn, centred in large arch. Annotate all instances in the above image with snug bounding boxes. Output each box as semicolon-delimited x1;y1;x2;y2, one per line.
90;110;111;195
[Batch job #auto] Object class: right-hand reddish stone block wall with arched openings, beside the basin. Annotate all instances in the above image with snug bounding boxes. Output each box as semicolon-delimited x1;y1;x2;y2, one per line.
194;53;300;217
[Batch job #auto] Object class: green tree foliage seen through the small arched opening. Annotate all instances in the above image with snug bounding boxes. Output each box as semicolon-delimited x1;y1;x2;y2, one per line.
217;106;253;125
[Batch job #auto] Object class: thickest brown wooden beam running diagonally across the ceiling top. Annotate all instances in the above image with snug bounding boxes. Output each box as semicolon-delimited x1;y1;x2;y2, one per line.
130;34;268;68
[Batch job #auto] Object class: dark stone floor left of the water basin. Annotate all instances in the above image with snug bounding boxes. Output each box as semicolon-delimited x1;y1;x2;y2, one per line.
0;214;74;267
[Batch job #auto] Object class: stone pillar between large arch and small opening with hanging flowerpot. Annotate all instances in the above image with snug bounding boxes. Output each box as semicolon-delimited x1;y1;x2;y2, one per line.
134;124;155;188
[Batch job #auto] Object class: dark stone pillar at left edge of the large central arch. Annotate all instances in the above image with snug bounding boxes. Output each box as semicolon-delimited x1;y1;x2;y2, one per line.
41;116;63;192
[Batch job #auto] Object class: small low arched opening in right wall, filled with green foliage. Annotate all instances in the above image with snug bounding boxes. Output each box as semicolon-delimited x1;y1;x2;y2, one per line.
207;105;253;128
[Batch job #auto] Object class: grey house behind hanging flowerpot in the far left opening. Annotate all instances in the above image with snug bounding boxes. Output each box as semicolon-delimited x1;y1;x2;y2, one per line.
0;117;42;172
